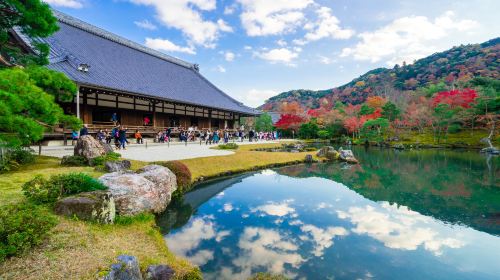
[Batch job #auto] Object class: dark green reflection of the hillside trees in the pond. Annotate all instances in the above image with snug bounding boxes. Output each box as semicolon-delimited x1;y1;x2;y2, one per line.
278;149;500;235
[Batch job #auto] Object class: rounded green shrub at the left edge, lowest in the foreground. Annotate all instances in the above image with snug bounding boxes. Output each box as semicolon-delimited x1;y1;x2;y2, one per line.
0;204;57;263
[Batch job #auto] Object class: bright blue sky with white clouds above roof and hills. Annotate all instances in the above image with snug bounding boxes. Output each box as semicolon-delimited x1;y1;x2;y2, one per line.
45;0;500;106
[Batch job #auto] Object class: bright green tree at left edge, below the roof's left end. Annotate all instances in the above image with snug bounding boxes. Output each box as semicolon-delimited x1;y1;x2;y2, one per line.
0;68;81;147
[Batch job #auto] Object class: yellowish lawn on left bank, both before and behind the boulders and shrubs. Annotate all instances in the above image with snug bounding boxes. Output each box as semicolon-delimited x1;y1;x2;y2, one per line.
0;156;196;279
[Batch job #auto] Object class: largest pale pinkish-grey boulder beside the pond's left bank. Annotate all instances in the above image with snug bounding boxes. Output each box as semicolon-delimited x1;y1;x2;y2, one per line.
99;165;177;216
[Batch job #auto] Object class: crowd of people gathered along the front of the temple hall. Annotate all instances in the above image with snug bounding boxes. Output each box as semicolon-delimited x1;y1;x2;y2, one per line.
72;122;281;150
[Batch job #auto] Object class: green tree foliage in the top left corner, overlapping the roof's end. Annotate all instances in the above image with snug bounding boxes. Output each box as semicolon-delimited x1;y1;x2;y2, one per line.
0;0;59;65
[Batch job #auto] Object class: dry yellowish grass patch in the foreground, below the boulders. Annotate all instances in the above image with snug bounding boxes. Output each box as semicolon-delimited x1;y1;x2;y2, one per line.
0;215;199;279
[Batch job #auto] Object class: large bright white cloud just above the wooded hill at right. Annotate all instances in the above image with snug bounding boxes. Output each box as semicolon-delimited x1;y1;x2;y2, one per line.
340;11;479;66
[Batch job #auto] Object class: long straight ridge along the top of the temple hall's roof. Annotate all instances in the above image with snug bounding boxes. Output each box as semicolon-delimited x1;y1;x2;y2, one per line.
52;9;195;69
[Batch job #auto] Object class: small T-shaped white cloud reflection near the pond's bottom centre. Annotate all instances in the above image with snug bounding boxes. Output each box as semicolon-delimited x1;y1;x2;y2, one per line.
300;225;349;257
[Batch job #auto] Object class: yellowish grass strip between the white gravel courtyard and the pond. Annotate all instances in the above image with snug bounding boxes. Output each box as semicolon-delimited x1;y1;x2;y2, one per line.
180;144;315;182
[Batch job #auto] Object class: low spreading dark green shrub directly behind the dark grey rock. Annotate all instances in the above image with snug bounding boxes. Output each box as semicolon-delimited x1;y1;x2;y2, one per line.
22;173;106;203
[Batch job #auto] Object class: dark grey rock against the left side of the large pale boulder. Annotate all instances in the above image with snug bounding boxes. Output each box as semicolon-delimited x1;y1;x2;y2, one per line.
54;191;116;224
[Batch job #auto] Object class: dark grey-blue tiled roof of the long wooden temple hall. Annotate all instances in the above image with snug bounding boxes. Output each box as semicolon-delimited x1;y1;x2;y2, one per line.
24;11;259;115
